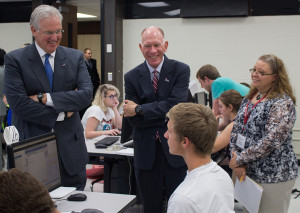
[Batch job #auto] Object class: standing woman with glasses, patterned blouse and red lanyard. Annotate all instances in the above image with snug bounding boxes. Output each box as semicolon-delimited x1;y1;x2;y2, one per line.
229;55;298;213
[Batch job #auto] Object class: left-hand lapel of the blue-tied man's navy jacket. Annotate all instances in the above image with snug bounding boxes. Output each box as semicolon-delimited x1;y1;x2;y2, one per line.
29;43;51;92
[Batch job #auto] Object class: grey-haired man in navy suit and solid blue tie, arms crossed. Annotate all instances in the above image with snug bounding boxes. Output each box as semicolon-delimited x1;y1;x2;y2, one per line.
5;5;92;190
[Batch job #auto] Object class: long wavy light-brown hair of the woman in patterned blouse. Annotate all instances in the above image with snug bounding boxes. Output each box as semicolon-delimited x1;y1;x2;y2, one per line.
247;54;296;104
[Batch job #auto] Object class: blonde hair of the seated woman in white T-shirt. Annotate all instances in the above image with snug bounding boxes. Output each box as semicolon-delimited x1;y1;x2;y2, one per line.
92;84;120;113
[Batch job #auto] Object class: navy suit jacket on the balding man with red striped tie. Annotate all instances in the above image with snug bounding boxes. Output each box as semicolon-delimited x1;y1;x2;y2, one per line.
124;56;190;169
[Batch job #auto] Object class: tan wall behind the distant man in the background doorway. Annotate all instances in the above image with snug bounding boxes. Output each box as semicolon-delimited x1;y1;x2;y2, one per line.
78;34;101;78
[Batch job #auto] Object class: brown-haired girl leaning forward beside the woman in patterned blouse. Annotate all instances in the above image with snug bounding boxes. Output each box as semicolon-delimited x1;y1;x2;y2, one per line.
212;90;243;153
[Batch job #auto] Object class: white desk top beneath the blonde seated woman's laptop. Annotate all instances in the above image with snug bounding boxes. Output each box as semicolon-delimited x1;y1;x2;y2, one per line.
85;136;134;157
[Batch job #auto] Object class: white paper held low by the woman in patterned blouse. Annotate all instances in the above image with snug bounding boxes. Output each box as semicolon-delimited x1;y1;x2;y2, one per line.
234;176;263;213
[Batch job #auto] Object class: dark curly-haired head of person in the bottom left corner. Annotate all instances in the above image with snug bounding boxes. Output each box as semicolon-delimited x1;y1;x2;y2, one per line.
0;169;59;213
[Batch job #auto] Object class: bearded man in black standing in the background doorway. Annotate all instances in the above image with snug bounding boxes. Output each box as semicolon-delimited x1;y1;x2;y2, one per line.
83;48;100;97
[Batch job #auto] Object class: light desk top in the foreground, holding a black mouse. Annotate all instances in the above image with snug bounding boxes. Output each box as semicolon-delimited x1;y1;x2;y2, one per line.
55;191;136;213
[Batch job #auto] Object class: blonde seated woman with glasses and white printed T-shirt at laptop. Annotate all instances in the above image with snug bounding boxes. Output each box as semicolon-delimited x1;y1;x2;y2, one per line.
81;84;122;139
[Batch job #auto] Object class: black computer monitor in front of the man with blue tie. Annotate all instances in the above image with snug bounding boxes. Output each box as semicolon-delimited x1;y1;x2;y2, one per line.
7;132;61;191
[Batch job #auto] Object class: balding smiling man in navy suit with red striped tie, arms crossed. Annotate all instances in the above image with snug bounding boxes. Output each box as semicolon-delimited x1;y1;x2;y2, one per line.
123;26;190;212
